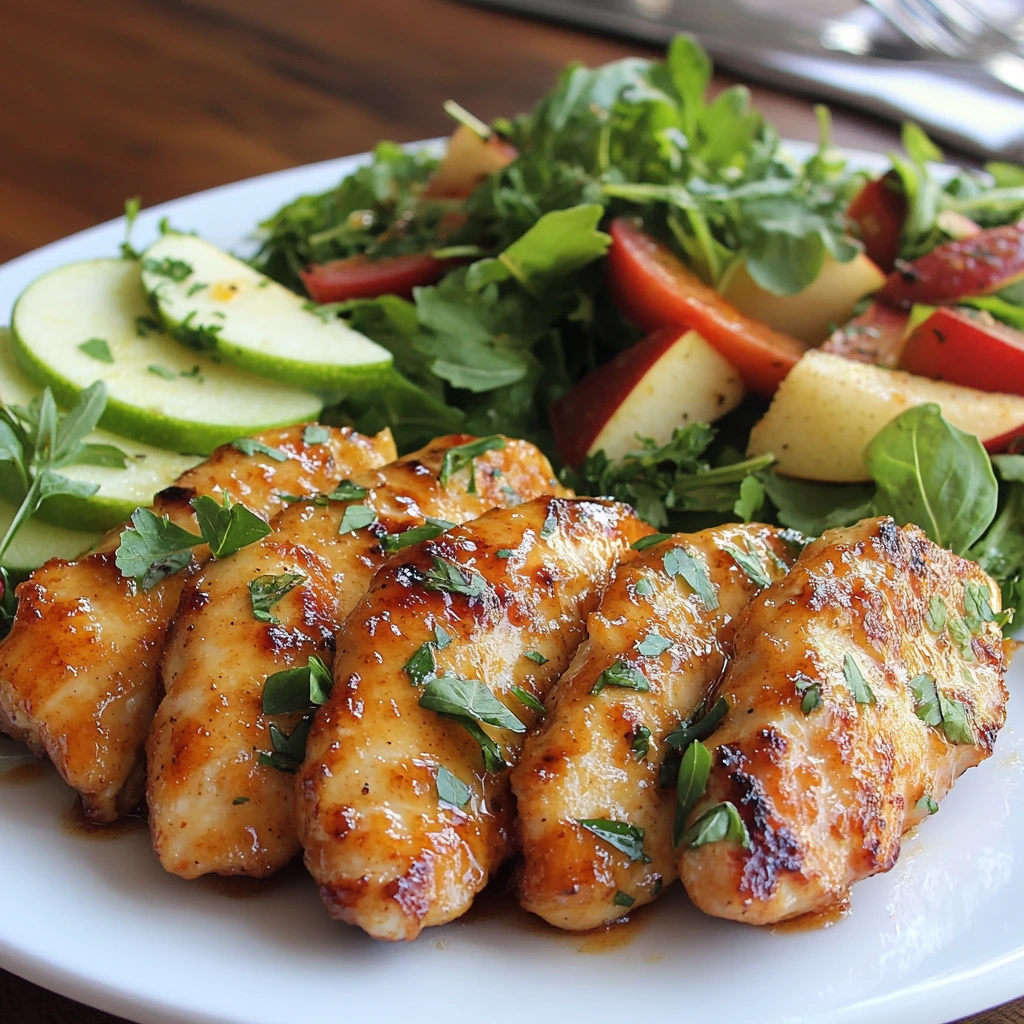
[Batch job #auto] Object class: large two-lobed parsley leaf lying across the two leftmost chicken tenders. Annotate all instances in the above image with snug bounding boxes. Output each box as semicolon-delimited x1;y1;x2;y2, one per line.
115;492;270;590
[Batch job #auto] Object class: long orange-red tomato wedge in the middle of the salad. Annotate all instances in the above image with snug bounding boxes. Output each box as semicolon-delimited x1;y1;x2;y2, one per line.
608;217;807;395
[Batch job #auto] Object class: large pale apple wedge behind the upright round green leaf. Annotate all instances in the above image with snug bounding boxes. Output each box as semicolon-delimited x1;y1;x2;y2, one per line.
748;349;1024;483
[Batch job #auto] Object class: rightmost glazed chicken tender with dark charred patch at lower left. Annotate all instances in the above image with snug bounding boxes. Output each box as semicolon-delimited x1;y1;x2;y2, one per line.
679;518;1007;925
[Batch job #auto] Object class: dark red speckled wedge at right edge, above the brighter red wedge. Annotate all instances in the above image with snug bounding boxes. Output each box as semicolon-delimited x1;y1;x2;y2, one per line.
876;222;1024;309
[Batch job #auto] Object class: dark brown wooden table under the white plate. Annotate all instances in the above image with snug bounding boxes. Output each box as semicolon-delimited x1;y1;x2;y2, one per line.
0;0;1024;1024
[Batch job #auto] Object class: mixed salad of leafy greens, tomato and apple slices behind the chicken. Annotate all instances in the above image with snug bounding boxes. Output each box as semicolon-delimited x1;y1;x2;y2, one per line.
0;36;1024;625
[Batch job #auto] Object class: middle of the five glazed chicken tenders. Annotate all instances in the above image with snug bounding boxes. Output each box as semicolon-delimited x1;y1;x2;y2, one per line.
298;498;651;940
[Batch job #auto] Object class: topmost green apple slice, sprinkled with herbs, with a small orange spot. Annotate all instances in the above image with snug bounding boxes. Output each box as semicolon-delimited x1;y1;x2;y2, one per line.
142;232;391;392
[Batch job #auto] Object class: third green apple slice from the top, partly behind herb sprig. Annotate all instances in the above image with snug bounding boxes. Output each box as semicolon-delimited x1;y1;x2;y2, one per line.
0;327;199;536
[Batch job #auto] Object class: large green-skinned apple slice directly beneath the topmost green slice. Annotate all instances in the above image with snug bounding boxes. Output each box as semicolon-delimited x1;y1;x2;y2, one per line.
11;259;323;455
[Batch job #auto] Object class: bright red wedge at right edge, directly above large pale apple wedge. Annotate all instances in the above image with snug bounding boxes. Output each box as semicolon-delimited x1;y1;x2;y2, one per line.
899;309;1024;395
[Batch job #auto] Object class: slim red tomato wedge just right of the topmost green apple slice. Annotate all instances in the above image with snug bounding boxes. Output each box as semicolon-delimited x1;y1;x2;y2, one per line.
299;253;457;302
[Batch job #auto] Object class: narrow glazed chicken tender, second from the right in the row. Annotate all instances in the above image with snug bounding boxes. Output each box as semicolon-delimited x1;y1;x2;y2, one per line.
512;524;794;930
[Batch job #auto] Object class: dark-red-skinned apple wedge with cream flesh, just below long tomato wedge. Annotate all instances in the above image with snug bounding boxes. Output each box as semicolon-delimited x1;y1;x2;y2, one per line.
551;327;743;466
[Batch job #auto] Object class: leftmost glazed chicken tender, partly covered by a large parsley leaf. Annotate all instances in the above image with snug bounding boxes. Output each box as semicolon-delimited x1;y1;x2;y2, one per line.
0;425;395;821
